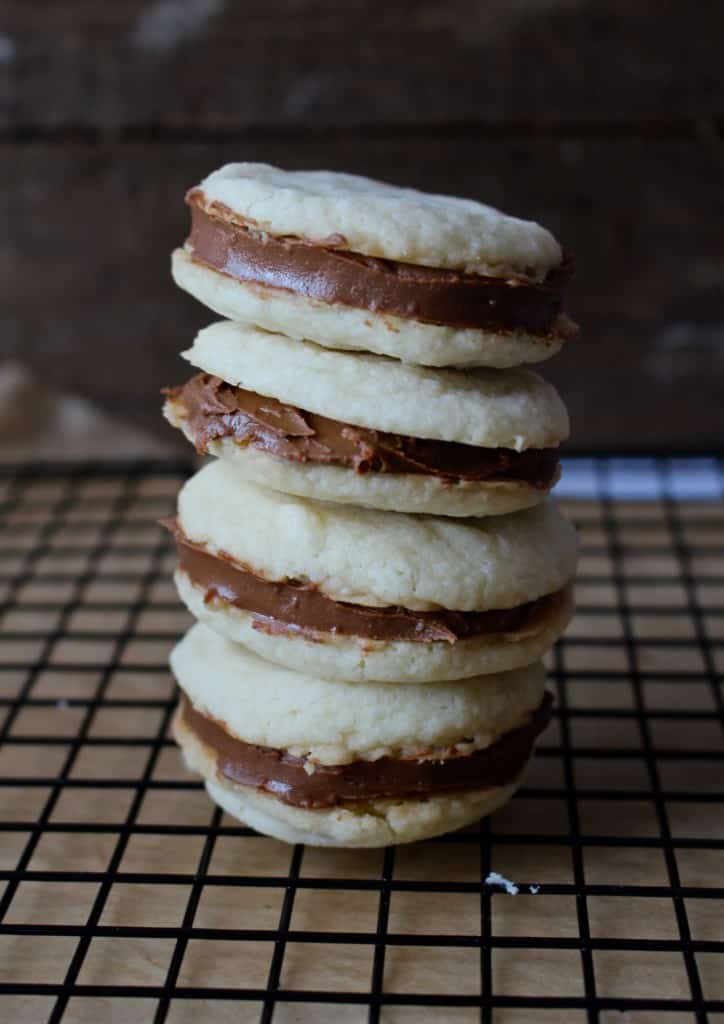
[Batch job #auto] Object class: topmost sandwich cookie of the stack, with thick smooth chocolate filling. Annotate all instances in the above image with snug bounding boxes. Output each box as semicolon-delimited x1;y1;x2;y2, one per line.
172;164;578;368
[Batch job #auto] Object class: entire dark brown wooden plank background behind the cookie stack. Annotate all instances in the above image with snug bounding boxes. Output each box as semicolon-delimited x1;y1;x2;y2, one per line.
0;0;724;449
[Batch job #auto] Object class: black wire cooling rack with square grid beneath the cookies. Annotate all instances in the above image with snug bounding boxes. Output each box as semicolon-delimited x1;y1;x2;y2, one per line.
0;459;724;1024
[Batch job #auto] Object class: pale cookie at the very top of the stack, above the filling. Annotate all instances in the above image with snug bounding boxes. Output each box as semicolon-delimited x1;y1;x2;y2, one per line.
199;164;563;281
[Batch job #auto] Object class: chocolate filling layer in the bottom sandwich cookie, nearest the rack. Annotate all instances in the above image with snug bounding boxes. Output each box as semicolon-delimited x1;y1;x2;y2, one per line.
181;693;553;809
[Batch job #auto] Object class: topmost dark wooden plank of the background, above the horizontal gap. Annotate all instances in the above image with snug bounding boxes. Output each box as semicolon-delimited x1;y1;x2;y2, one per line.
0;0;724;130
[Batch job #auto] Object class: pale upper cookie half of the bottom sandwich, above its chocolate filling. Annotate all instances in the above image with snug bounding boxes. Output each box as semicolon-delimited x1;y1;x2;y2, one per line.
171;624;545;765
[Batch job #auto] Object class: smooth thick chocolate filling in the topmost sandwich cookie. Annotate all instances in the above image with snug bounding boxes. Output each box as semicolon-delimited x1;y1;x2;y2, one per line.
186;189;573;336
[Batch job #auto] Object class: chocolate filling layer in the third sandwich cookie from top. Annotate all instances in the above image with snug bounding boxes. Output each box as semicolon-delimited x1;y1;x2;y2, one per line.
165;521;561;643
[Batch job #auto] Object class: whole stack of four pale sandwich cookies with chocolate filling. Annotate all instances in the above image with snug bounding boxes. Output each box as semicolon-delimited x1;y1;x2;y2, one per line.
165;165;576;846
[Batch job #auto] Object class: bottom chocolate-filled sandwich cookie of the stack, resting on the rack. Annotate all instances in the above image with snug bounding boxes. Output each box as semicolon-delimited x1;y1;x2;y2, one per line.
171;625;551;847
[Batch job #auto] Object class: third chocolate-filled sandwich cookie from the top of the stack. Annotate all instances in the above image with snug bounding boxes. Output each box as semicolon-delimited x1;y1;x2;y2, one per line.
168;461;577;683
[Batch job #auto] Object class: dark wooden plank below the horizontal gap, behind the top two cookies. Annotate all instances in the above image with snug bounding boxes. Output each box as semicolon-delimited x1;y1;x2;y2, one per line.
0;134;724;446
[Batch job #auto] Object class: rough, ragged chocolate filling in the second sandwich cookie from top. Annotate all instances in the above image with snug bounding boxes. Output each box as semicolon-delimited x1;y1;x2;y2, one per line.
165;374;558;489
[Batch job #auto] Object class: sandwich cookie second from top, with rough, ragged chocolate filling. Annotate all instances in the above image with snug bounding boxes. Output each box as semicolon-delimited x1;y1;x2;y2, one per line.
164;321;568;516
